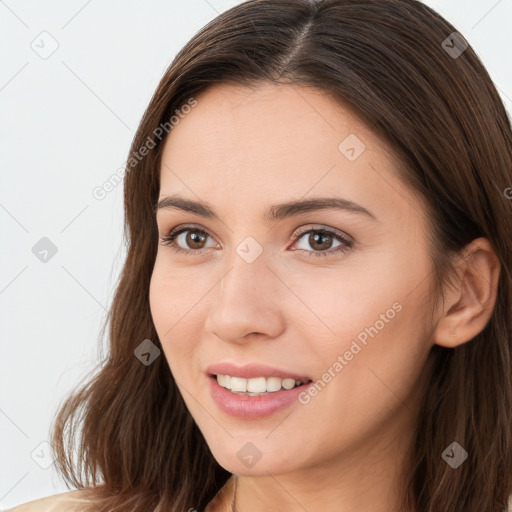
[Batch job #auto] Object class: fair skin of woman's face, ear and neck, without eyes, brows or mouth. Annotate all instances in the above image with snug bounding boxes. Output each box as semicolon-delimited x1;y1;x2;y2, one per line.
150;84;500;512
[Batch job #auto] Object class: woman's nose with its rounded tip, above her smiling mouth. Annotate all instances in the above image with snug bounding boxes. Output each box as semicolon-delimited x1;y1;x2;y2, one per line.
205;254;291;343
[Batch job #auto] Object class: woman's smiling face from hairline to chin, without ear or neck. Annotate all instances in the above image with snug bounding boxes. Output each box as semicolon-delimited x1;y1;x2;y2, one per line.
150;85;433;475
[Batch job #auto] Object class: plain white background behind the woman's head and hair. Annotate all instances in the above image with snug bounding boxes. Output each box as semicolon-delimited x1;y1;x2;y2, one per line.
0;0;512;509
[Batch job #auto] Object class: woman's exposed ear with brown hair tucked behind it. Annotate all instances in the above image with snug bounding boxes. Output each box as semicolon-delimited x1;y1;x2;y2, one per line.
433;238;501;348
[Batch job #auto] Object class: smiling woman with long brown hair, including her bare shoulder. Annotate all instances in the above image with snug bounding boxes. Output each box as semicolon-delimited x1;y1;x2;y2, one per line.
9;0;512;512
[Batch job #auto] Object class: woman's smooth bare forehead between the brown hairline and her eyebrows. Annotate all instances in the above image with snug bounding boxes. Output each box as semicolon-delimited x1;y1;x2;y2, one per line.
160;84;428;227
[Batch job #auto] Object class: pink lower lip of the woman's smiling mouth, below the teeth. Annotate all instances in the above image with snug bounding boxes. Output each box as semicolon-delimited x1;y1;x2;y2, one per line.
208;375;313;419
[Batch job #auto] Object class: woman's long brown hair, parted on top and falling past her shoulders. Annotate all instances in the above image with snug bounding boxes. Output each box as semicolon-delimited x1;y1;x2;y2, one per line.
52;0;512;512
